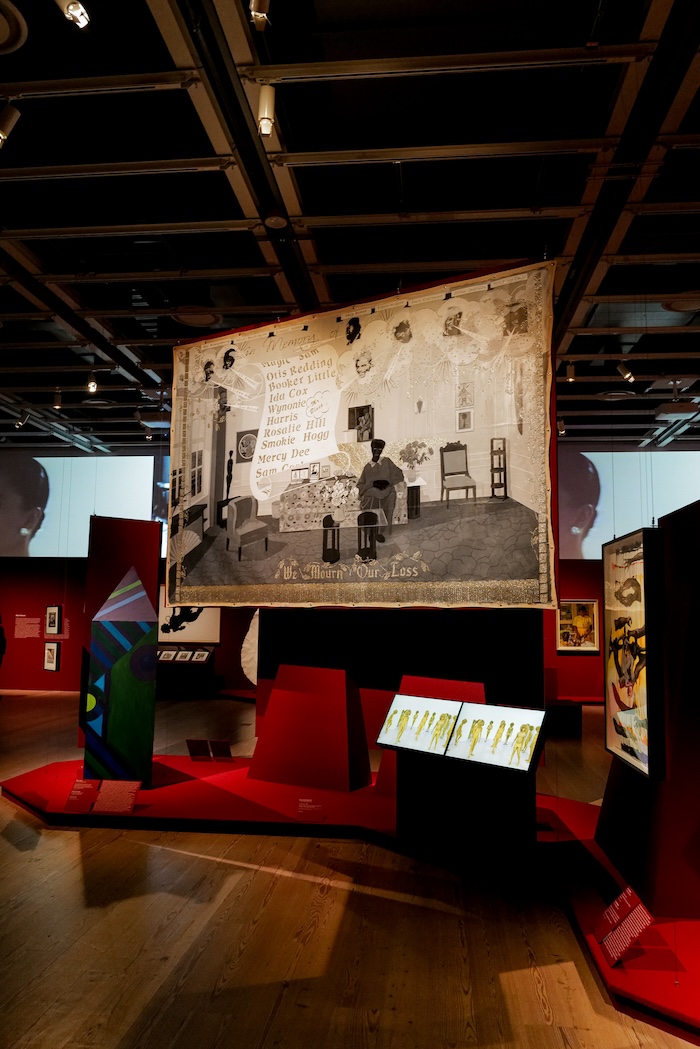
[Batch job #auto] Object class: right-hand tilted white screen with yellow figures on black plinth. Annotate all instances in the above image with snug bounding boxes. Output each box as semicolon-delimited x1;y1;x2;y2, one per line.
447;703;545;772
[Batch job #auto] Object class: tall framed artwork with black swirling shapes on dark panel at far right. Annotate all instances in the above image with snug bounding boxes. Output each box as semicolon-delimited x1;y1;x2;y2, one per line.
602;529;665;777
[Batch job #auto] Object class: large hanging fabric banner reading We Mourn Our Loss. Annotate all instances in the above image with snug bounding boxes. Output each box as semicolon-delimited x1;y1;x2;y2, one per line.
168;263;555;607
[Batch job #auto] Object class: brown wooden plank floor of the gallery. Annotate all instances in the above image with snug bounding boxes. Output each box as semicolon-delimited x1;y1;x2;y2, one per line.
0;693;687;1049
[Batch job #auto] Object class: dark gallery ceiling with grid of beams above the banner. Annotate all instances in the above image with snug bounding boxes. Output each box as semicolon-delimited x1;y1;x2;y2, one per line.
0;0;700;452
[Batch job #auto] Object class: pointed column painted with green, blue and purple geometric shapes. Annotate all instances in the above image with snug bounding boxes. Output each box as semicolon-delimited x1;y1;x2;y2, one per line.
80;569;157;787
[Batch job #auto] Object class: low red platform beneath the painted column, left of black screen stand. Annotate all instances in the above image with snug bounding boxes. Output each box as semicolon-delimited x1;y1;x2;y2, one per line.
0;755;396;834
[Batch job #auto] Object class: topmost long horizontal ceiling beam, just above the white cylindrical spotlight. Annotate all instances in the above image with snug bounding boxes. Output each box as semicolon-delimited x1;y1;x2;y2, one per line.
238;42;655;84
